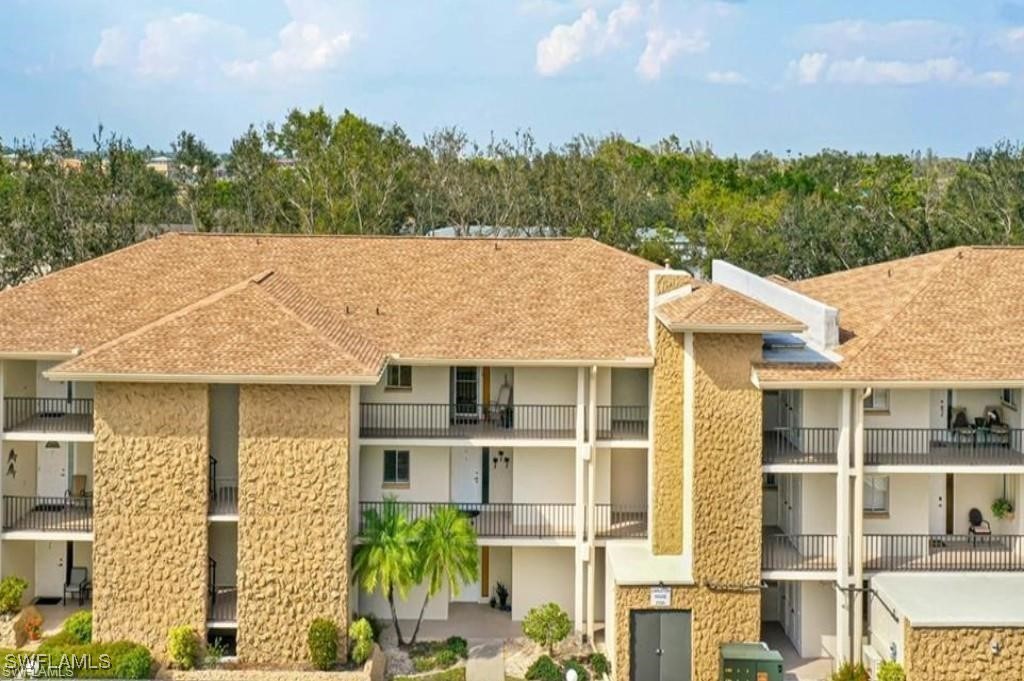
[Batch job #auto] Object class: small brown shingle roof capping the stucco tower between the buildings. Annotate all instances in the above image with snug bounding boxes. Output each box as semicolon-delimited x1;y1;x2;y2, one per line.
655;283;807;333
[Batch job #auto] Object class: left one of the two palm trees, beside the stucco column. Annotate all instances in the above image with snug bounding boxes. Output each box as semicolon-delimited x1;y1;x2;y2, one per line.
352;498;423;645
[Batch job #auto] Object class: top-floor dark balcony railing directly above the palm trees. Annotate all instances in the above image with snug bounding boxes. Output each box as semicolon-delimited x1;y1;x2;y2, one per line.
359;402;575;439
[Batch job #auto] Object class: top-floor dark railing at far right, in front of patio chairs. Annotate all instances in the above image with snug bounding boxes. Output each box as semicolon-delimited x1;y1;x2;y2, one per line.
864;426;1024;466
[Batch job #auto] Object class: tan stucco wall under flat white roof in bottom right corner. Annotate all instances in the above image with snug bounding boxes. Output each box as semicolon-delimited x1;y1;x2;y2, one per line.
904;623;1024;681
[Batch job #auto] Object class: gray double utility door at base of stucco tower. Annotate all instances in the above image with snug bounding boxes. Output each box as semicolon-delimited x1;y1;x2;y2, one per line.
630;610;692;681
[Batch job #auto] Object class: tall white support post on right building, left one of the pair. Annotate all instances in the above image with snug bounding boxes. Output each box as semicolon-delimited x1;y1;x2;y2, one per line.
836;389;853;665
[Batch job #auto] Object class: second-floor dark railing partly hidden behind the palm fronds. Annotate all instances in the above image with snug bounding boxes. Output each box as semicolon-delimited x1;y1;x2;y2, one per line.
359;502;575;539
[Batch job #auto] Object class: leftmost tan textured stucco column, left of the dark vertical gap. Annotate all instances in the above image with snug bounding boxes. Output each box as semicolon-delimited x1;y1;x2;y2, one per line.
92;383;209;657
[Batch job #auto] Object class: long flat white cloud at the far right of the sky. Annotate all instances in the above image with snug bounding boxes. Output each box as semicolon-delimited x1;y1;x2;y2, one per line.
790;52;1011;85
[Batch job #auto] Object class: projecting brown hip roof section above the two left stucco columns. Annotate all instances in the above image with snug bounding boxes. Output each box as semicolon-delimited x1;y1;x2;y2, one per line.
50;272;385;383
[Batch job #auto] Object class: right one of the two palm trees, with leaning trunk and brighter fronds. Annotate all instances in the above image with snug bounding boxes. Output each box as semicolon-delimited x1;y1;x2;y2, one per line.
409;506;479;645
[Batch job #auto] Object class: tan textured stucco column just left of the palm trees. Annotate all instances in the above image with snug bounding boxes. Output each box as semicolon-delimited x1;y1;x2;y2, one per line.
238;385;350;665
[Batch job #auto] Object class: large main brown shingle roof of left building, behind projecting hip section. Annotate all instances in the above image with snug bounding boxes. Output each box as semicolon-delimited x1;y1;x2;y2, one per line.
0;235;657;361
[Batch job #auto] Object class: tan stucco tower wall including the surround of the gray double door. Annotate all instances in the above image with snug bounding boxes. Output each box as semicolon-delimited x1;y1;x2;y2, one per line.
613;334;762;681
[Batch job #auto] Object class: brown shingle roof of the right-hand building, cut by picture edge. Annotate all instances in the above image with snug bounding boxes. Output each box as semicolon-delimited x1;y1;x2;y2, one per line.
758;247;1024;383
